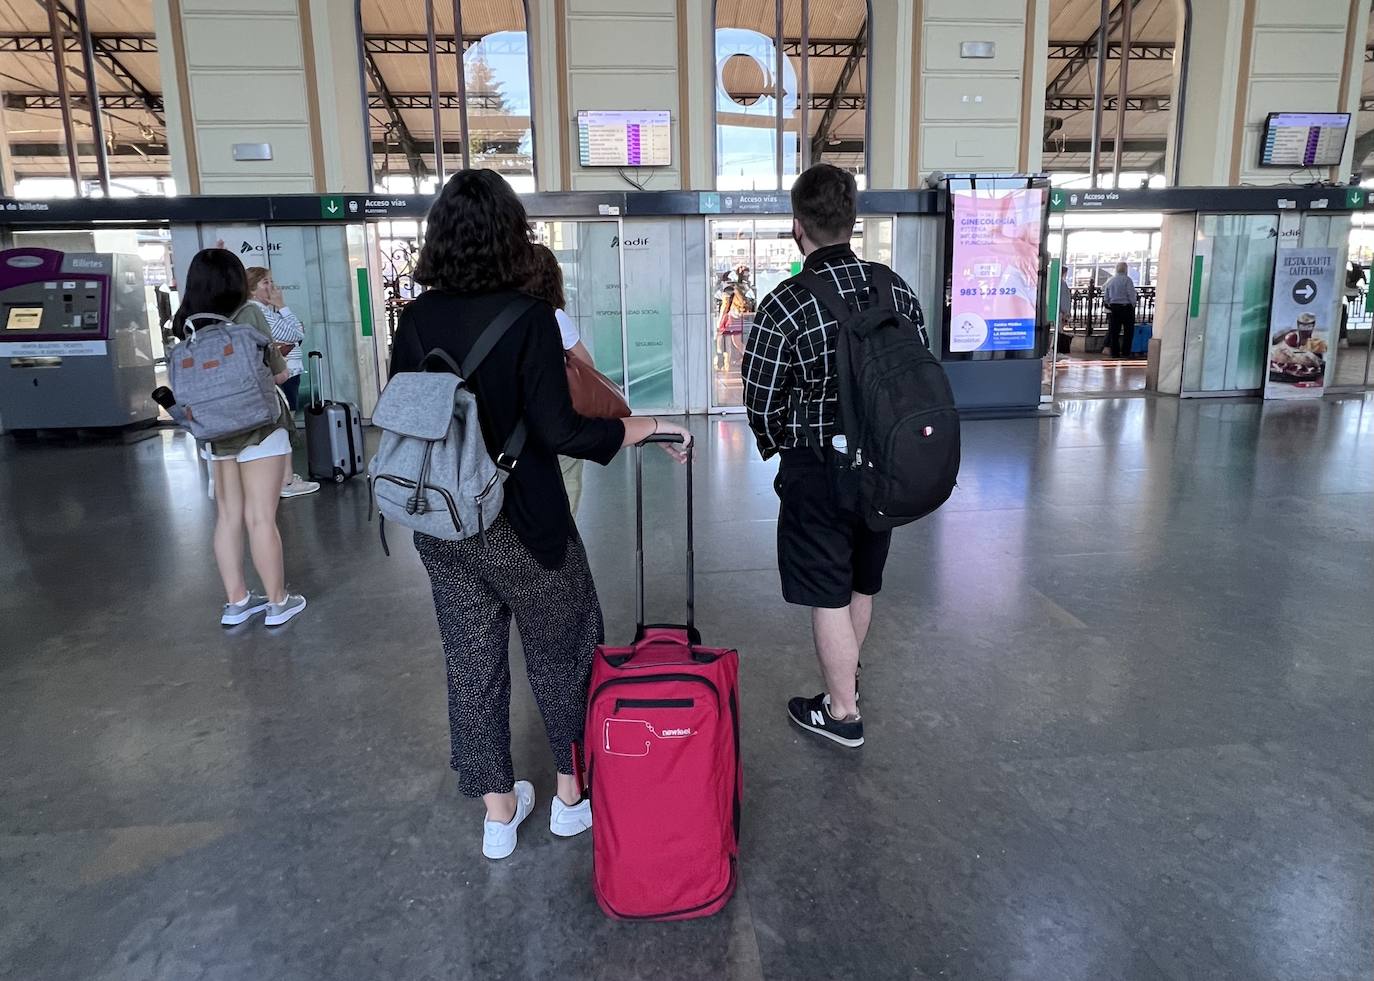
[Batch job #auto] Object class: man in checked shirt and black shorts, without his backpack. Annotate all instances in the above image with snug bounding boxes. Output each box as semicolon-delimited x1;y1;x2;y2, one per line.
741;164;929;746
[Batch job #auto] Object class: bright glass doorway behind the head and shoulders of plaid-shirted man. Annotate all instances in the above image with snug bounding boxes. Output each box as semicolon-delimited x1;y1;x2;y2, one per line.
706;217;893;411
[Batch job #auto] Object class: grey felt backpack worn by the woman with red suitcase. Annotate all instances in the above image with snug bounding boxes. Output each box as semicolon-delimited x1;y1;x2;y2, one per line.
367;297;534;555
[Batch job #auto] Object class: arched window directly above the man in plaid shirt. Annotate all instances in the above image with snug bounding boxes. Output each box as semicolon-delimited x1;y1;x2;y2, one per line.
714;0;870;190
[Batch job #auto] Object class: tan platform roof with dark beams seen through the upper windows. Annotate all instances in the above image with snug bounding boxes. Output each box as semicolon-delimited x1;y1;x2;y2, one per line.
0;0;1374;185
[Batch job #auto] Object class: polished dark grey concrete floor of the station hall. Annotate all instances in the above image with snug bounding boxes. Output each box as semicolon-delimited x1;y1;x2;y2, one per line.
0;398;1374;981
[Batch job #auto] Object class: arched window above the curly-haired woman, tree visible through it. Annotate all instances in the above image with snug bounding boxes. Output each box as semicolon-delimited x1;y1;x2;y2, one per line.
359;0;534;192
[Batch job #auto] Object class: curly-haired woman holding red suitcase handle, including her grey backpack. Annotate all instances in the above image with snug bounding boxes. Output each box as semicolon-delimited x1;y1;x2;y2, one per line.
381;170;691;859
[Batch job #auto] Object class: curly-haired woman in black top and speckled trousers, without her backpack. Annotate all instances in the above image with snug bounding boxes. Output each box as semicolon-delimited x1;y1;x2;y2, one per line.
392;170;691;859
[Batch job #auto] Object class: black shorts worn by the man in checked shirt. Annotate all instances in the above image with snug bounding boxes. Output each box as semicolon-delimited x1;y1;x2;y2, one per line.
774;449;892;610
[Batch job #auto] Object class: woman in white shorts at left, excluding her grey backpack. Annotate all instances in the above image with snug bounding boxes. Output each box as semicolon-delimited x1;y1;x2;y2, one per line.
172;249;305;627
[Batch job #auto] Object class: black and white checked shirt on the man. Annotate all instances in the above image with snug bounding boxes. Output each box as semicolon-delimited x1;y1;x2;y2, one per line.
741;245;930;459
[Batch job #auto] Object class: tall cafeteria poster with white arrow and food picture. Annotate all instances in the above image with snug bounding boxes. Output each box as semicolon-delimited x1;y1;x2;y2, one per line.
1264;247;1341;398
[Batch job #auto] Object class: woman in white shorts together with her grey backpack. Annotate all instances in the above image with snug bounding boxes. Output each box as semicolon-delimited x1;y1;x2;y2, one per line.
168;249;305;627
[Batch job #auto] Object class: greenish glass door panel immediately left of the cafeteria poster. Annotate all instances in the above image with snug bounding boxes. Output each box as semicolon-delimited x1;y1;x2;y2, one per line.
1182;214;1279;396
